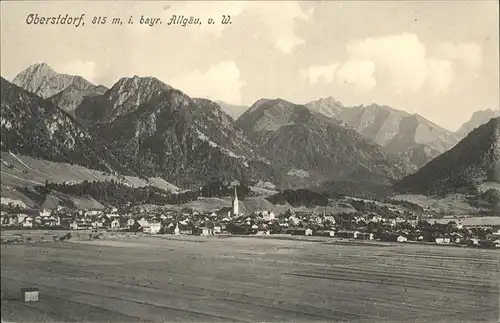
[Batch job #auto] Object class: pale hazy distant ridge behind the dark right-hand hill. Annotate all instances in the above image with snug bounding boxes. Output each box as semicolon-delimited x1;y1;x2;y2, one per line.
308;100;458;167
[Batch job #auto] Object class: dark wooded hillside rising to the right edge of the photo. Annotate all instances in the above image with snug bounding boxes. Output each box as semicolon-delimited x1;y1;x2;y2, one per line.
395;117;500;195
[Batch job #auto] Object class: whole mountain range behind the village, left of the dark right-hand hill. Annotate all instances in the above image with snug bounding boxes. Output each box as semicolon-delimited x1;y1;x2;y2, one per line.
1;64;496;201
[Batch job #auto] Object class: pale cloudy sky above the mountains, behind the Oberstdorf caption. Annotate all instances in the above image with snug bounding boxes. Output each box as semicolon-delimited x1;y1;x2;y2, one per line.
0;0;500;131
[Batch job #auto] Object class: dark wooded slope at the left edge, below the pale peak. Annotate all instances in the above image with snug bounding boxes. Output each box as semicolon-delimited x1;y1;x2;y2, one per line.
0;78;131;176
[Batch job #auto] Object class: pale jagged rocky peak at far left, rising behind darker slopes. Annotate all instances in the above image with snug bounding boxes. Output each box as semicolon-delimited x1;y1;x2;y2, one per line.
12;63;95;99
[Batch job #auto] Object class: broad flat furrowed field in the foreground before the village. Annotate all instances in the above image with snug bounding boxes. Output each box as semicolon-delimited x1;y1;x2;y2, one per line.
1;236;500;322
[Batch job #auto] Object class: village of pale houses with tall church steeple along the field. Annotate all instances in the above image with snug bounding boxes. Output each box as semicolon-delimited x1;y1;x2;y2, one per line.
1;187;500;248
